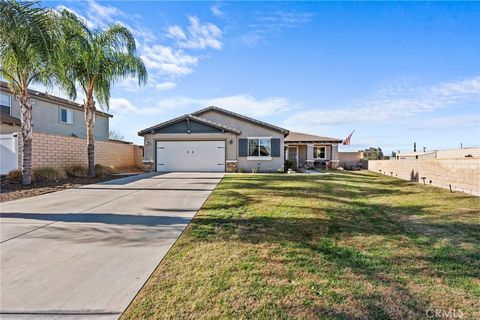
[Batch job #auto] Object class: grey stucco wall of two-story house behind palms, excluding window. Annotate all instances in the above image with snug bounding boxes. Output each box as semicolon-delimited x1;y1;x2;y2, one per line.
2;92;109;141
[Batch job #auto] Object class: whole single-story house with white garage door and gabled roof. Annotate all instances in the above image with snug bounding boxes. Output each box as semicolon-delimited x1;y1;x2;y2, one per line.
138;106;341;172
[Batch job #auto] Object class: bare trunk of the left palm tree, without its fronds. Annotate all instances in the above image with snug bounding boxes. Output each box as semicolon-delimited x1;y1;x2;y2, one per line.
18;89;33;185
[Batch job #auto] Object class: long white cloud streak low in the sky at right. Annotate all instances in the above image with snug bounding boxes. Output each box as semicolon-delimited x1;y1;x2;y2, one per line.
286;77;480;129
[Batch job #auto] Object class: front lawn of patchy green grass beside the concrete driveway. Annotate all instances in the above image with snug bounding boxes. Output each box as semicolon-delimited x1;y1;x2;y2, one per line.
123;172;480;319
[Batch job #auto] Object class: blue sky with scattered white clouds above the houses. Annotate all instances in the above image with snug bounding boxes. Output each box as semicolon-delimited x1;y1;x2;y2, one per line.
43;1;480;153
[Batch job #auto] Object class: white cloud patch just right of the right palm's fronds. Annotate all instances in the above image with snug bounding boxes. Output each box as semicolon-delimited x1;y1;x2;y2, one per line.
141;44;198;76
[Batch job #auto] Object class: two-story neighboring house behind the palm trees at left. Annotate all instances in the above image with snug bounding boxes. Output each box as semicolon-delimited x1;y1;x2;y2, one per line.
0;82;112;141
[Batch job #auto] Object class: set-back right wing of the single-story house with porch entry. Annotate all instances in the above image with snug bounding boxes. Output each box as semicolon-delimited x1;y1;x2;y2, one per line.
285;132;342;168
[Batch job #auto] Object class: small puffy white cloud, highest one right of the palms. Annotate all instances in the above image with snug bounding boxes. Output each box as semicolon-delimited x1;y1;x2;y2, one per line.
167;16;222;50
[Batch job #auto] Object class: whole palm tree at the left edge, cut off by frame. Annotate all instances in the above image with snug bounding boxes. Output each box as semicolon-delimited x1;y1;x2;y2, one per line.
0;0;54;184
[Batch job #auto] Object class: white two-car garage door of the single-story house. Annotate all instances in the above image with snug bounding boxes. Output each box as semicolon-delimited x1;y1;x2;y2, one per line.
157;141;225;172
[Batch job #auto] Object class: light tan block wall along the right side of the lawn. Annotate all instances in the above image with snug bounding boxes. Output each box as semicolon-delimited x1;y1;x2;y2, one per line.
368;158;480;196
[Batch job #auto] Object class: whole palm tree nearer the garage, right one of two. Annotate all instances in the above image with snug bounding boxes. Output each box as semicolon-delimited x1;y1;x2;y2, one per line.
57;10;147;177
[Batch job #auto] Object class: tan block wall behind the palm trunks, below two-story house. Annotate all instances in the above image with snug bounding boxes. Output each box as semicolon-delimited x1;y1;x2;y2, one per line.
27;133;143;168
